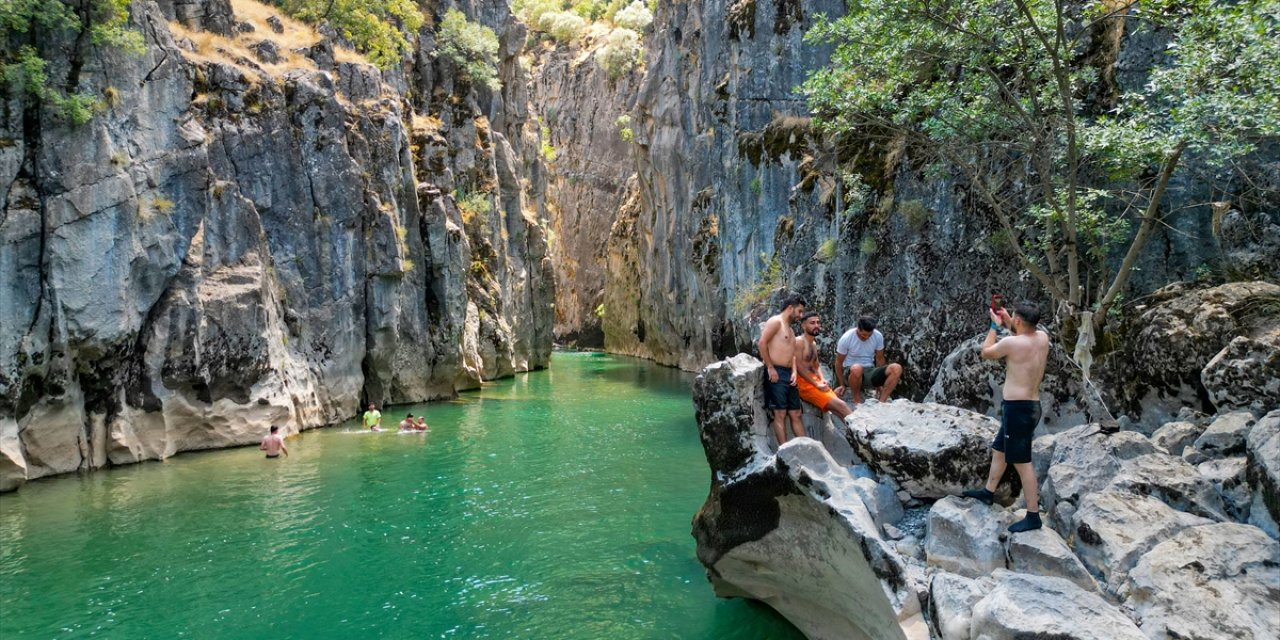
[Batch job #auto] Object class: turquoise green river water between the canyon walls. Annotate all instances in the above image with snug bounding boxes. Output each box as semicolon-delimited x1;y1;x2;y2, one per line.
0;353;800;640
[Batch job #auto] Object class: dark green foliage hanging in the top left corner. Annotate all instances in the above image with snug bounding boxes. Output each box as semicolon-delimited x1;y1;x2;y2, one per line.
0;0;145;124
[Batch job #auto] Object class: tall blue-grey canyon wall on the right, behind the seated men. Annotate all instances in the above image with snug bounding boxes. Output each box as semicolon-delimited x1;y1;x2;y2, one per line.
535;0;1280;408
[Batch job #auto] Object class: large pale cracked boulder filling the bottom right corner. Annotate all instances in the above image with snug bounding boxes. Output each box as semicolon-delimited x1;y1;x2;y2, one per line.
1125;524;1280;640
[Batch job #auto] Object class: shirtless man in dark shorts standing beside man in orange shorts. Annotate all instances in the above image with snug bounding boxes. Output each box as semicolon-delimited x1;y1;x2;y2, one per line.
756;296;805;447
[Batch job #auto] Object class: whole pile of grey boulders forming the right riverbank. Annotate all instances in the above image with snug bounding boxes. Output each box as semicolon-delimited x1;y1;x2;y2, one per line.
692;355;1280;640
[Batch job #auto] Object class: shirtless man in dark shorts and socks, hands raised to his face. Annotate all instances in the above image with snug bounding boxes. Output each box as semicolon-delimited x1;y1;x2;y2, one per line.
964;302;1048;534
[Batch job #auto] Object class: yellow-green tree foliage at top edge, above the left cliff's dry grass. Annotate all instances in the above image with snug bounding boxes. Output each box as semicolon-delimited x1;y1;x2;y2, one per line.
273;0;422;69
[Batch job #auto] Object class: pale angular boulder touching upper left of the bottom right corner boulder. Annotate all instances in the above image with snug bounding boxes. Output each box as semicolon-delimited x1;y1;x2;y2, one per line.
1069;490;1210;591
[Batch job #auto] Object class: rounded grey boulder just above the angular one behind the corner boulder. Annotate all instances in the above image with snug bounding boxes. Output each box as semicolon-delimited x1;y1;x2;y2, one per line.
1108;453;1229;521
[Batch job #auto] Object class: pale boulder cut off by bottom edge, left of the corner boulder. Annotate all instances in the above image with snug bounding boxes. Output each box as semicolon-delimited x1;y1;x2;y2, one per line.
969;570;1146;640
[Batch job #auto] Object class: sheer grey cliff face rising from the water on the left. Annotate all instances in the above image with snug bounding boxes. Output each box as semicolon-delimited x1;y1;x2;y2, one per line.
0;0;554;489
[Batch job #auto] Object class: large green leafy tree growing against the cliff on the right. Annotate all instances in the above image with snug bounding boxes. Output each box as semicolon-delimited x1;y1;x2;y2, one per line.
803;0;1280;326
